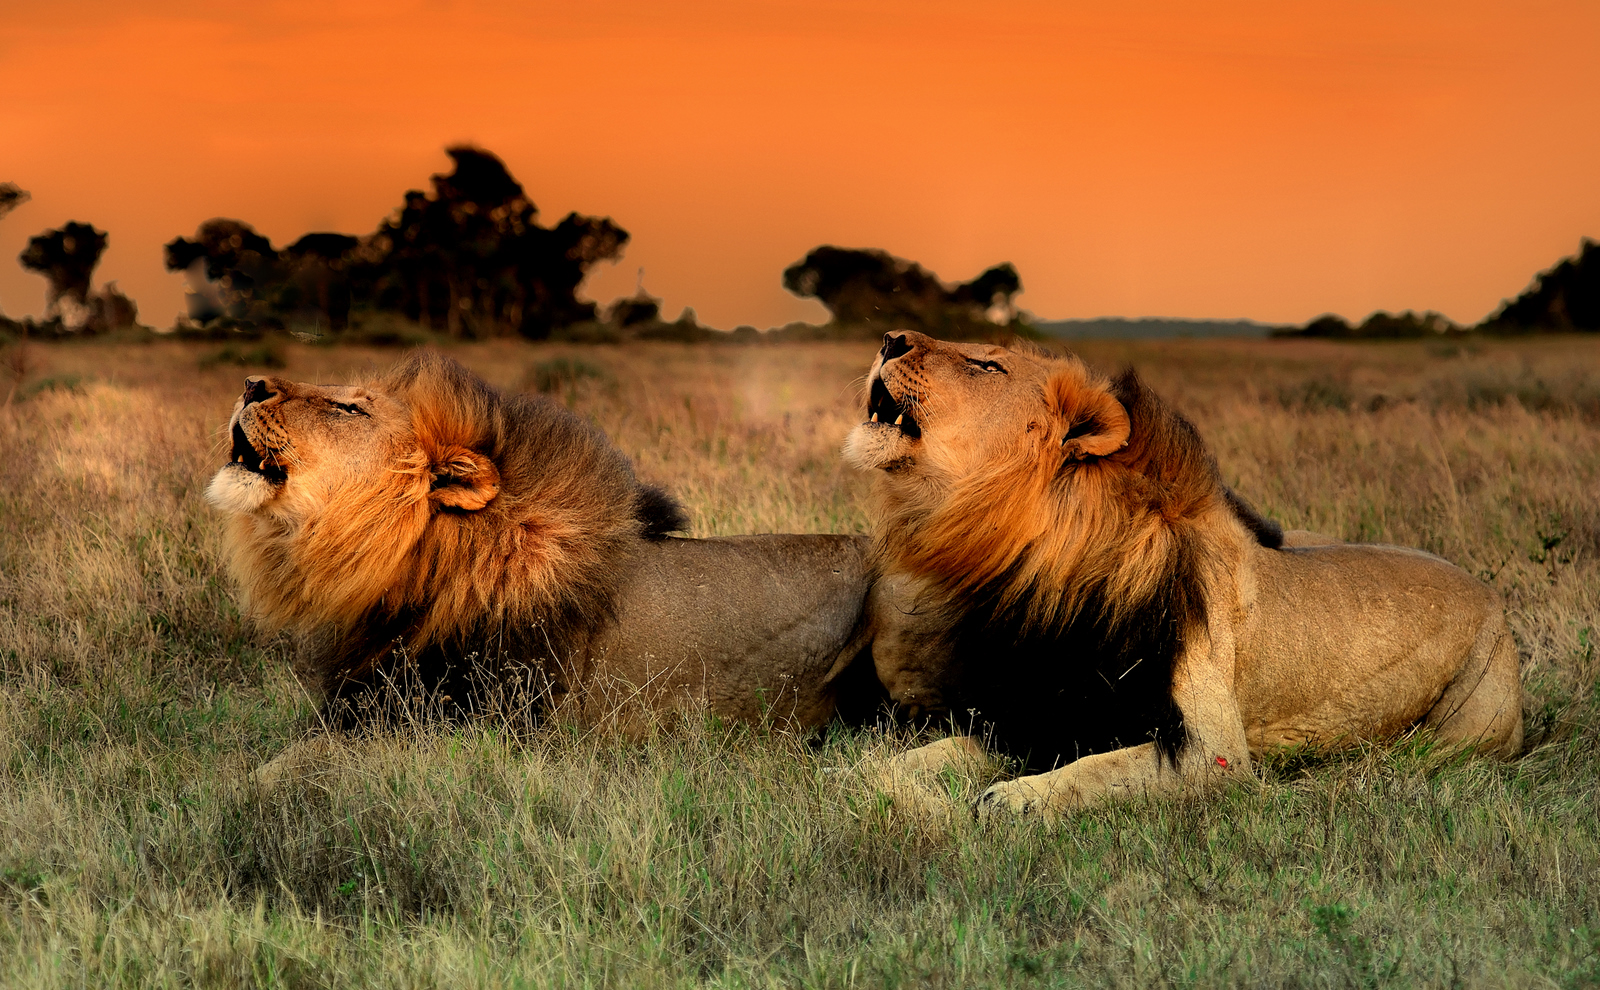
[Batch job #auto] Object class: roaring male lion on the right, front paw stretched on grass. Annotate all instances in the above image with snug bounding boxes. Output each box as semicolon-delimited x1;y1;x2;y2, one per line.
845;331;1522;814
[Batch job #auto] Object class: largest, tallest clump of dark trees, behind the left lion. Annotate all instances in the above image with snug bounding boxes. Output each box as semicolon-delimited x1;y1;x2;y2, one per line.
166;146;629;339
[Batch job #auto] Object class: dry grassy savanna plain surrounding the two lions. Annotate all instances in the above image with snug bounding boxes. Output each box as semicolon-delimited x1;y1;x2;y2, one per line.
0;337;1600;987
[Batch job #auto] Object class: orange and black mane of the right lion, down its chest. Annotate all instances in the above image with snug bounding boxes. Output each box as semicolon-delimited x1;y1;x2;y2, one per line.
875;349;1283;768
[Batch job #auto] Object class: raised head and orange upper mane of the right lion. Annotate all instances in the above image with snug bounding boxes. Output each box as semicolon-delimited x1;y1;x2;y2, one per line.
845;331;1274;625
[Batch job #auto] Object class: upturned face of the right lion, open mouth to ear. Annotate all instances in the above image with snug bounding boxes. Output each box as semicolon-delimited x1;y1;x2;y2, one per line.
845;331;1128;488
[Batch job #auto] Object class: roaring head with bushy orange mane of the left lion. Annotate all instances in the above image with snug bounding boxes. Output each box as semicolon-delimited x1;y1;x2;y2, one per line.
206;352;682;675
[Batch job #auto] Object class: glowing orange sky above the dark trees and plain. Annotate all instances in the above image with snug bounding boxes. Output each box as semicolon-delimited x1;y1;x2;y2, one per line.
0;0;1600;326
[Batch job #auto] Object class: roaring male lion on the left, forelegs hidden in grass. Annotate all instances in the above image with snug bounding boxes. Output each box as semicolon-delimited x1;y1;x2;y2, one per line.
206;352;869;748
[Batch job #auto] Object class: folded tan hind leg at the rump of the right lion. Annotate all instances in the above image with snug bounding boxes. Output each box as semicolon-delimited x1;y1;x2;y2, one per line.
1422;617;1522;756
